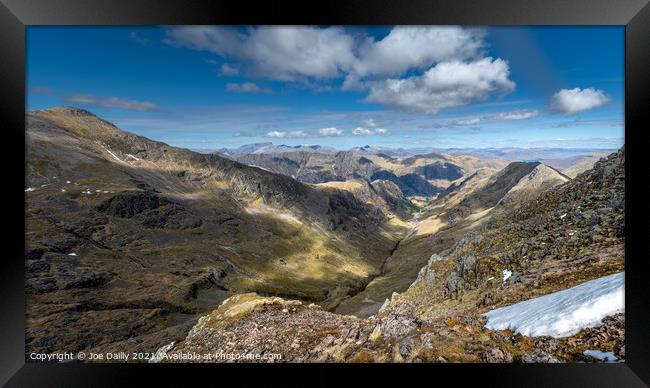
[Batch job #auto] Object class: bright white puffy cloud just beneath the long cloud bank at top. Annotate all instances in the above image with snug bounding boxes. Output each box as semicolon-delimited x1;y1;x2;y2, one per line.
366;58;515;113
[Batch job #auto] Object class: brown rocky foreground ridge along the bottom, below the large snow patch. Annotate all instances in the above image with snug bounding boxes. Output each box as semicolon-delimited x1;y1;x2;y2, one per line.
152;294;625;363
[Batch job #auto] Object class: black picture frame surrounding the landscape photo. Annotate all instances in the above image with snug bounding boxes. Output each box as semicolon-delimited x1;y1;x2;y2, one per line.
0;0;650;387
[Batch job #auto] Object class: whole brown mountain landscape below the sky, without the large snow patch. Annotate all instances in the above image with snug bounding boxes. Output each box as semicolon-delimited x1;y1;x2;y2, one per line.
25;106;624;362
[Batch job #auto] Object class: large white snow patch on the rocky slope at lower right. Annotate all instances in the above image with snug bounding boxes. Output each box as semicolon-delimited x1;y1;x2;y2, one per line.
485;272;625;338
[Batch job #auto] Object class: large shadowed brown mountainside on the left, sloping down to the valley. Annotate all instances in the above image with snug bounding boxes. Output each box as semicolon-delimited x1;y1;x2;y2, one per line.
25;107;405;358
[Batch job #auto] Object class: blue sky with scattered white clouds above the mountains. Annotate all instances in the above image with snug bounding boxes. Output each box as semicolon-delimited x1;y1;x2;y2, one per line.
27;26;624;149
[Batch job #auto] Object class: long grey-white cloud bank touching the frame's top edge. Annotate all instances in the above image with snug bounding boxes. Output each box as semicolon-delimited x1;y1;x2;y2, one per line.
163;26;485;81
